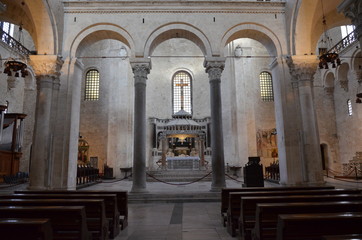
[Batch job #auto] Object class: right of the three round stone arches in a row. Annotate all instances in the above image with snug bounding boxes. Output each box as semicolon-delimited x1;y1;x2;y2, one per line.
220;23;283;56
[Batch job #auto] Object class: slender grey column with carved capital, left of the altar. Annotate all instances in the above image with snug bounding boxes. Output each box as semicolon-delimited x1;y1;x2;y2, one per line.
131;59;151;193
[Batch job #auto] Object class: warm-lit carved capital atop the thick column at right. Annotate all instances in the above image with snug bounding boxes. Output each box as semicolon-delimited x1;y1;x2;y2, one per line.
286;56;318;81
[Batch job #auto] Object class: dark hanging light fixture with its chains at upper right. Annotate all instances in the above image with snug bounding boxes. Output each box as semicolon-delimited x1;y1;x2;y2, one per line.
319;0;341;69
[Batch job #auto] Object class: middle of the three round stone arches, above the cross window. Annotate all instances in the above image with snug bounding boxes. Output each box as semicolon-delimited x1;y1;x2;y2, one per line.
143;23;212;57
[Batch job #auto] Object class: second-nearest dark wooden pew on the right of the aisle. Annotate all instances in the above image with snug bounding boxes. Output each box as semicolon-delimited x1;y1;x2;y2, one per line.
252;201;362;240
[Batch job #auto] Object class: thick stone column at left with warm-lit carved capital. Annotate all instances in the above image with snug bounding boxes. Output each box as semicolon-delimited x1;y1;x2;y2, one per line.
29;55;63;190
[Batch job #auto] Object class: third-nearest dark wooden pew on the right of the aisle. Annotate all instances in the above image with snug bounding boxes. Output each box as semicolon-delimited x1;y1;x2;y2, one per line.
239;194;362;239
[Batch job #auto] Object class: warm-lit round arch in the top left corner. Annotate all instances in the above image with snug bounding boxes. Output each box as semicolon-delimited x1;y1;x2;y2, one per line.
0;0;55;55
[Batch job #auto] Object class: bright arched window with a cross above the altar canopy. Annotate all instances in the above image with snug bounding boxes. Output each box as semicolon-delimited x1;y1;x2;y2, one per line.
172;71;192;114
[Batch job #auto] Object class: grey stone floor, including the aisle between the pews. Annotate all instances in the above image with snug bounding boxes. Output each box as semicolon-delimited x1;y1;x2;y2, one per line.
0;175;362;240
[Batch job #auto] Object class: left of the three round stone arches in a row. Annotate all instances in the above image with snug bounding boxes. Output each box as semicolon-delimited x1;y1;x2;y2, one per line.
70;23;135;57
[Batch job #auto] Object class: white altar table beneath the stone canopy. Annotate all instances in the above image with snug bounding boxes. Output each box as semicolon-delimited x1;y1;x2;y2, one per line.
166;156;200;170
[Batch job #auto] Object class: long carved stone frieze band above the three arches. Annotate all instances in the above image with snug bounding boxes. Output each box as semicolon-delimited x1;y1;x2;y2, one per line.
64;0;285;14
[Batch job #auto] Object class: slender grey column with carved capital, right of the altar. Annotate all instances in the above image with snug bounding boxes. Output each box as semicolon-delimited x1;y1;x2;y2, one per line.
204;58;226;191
